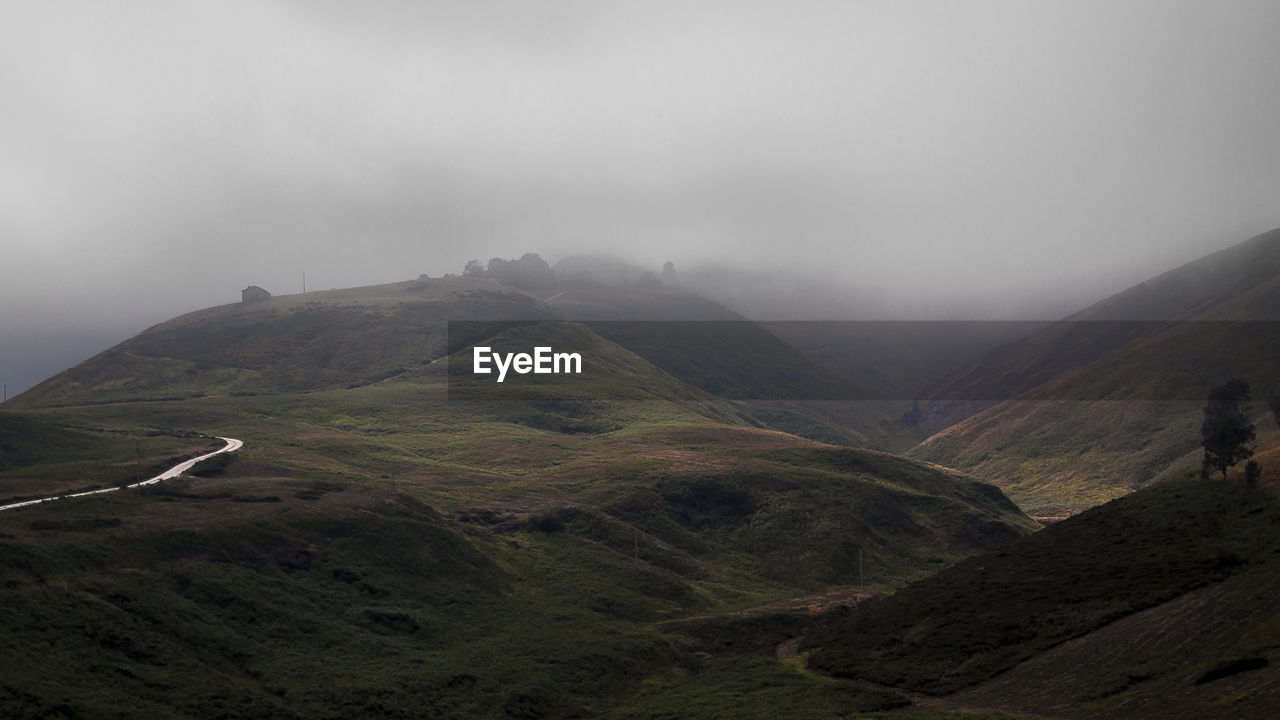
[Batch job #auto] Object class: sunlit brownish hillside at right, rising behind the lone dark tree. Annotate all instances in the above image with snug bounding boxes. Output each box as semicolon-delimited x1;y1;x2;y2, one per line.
910;226;1280;515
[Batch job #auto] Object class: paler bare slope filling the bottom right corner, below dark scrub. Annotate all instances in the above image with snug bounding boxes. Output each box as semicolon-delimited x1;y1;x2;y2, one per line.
955;566;1280;720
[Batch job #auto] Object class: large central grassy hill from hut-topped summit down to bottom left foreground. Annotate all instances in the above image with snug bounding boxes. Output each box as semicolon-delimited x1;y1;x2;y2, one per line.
0;279;1034;717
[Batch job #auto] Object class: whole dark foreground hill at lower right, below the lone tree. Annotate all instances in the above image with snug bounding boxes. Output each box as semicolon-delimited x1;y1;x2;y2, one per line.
801;478;1280;717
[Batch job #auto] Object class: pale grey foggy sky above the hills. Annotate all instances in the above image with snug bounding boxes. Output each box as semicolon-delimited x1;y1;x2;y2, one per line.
0;0;1280;396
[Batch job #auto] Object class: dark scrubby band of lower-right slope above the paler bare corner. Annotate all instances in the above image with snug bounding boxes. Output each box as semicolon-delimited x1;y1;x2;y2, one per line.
803;471;1280;716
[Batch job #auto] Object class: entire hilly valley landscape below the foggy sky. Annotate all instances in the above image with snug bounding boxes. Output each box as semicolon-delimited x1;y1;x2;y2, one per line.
0;234;1280;719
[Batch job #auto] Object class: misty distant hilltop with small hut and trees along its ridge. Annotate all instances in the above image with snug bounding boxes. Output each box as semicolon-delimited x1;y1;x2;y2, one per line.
13;278;890;445
